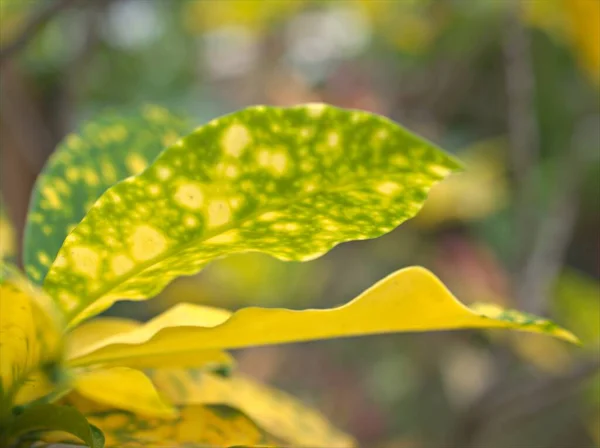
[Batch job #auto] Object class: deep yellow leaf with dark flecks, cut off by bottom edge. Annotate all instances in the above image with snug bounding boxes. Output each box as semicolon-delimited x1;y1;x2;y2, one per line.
62;394;275;448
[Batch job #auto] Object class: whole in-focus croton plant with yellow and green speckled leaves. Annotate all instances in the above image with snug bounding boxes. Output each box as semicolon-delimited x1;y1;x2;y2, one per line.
0;104;576;448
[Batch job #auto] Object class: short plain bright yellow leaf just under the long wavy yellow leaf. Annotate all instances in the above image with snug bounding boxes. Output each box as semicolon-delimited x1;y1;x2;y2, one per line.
74;367;177;418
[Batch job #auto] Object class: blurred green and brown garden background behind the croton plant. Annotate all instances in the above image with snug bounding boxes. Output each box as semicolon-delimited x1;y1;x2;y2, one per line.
0;0;600;448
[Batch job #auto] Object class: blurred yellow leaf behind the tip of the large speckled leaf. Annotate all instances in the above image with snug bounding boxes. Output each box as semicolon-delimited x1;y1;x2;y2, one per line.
414;139;508;227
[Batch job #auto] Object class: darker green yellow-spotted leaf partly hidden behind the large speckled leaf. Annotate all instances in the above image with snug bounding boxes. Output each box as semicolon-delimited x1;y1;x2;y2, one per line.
23;106;187;284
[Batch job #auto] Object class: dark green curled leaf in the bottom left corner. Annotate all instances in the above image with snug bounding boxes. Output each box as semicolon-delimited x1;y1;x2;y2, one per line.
9;404;104;448
